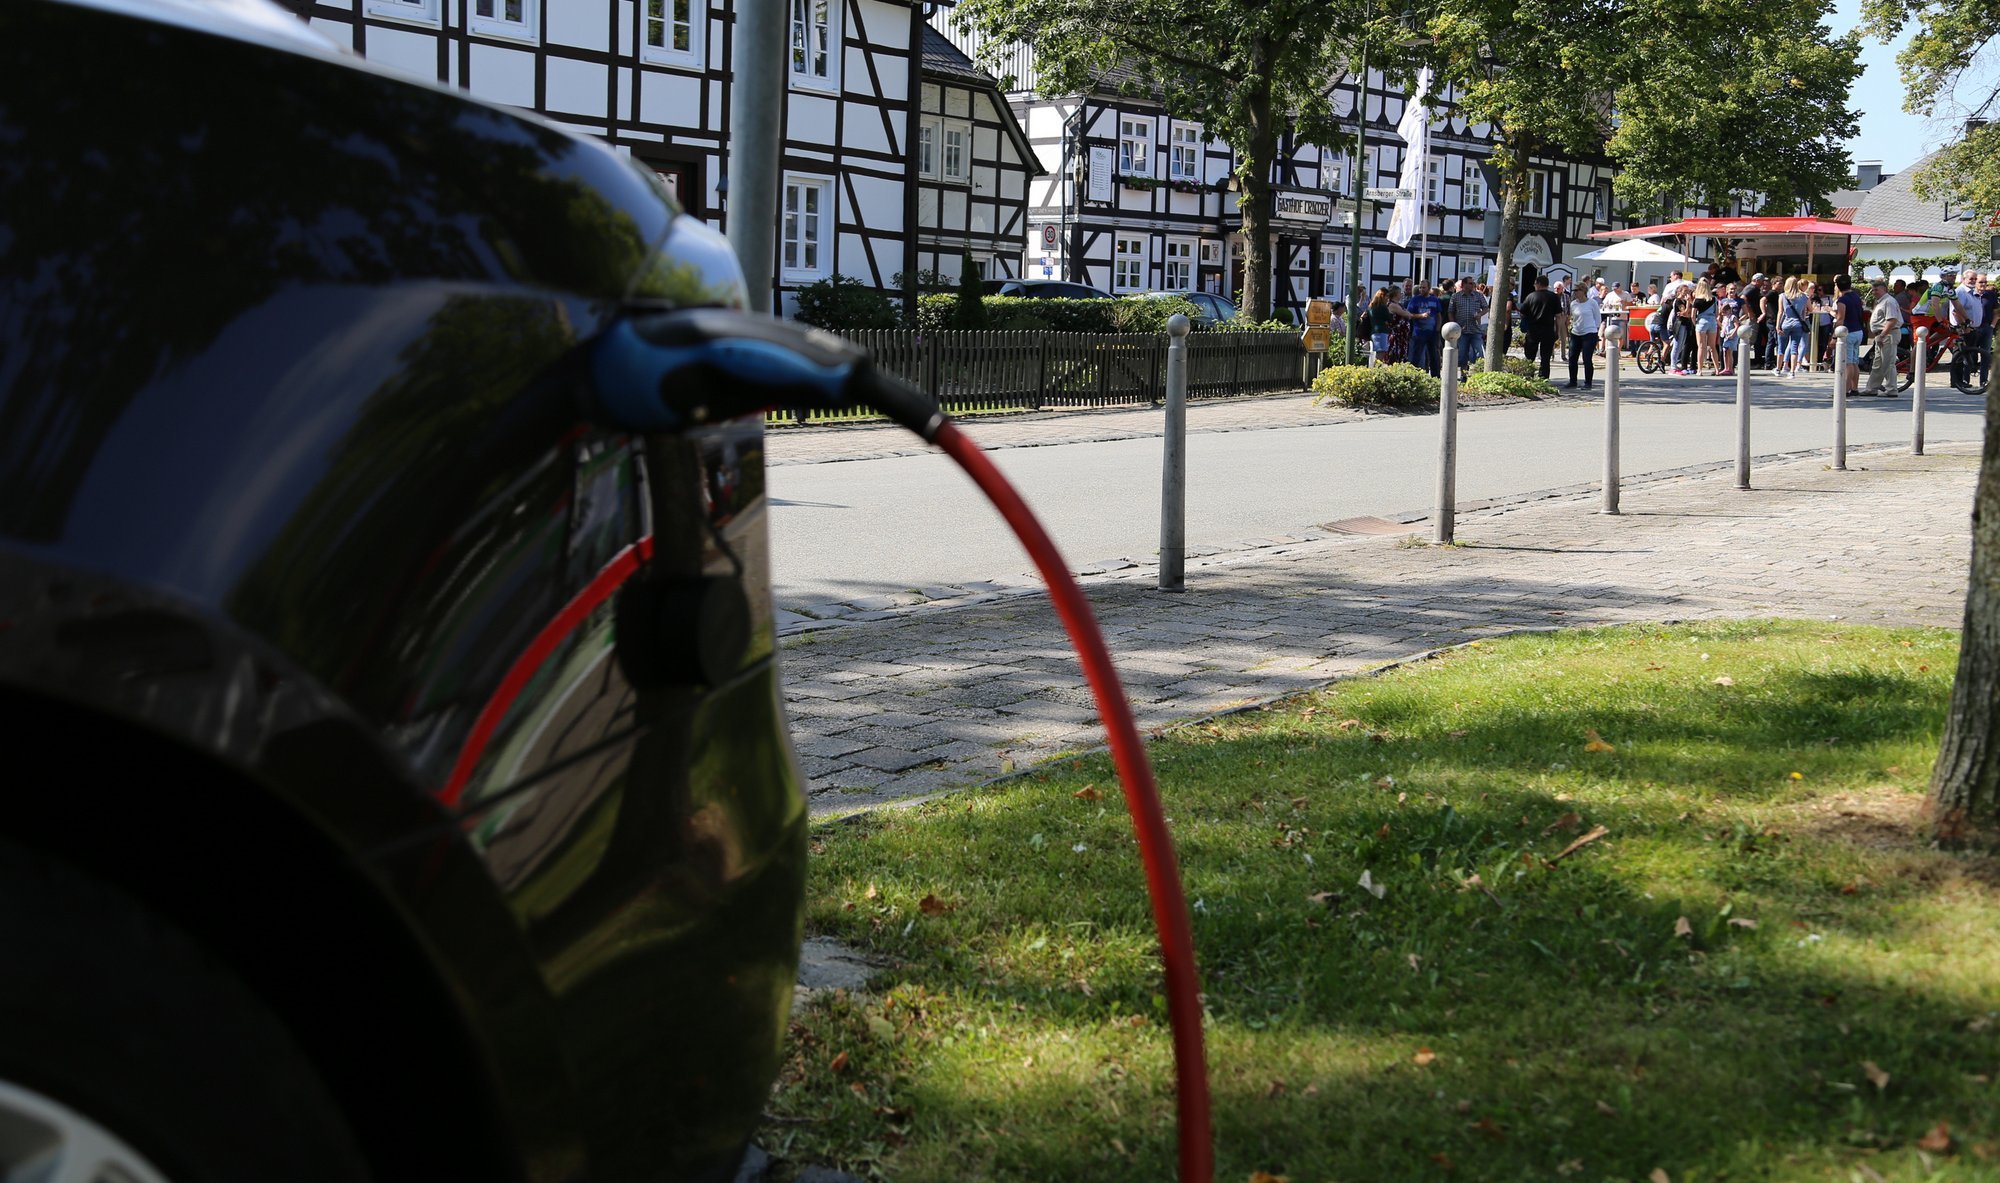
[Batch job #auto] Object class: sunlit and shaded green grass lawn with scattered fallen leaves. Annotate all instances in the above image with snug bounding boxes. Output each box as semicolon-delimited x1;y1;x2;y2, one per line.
764;621;2000;1183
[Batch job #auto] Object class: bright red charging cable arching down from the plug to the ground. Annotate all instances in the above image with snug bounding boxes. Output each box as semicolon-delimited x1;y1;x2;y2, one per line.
932;420;1216;1183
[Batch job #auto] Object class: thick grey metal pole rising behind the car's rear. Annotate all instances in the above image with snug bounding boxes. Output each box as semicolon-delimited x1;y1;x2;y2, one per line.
728;0;780;312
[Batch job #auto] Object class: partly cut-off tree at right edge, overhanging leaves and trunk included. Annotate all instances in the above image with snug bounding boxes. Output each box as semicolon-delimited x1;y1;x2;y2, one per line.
1864;0;2000;845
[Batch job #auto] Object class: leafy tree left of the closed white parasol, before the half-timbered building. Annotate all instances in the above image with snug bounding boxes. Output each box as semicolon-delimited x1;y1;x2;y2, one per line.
958;0;1360;320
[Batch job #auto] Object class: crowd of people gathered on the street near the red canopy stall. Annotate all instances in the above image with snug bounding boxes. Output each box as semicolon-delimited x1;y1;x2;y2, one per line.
1334;262;2000;396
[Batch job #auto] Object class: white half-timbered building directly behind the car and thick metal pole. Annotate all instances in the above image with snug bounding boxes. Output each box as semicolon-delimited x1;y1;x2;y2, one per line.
284;0;924;309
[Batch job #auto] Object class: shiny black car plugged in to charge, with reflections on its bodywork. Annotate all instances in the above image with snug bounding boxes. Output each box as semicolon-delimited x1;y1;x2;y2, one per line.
0;0;806;1183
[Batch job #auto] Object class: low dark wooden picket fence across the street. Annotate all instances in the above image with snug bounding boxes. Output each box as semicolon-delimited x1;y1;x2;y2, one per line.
772;330;1304;424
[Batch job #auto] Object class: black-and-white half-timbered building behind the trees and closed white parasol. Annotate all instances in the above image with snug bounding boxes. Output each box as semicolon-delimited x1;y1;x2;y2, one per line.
930;10;1752;308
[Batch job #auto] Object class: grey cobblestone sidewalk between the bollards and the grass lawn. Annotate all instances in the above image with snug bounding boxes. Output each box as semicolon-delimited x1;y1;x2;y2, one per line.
782;446;1978;815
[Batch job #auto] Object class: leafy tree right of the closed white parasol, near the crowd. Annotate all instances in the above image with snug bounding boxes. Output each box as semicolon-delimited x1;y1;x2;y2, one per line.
1424;0;1856;370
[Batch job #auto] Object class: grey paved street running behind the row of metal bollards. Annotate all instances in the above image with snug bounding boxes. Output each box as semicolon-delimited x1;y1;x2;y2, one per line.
768;376;1982;627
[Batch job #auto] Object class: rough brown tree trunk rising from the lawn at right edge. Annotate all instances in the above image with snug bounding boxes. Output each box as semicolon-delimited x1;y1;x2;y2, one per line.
1926;368;2000;845
